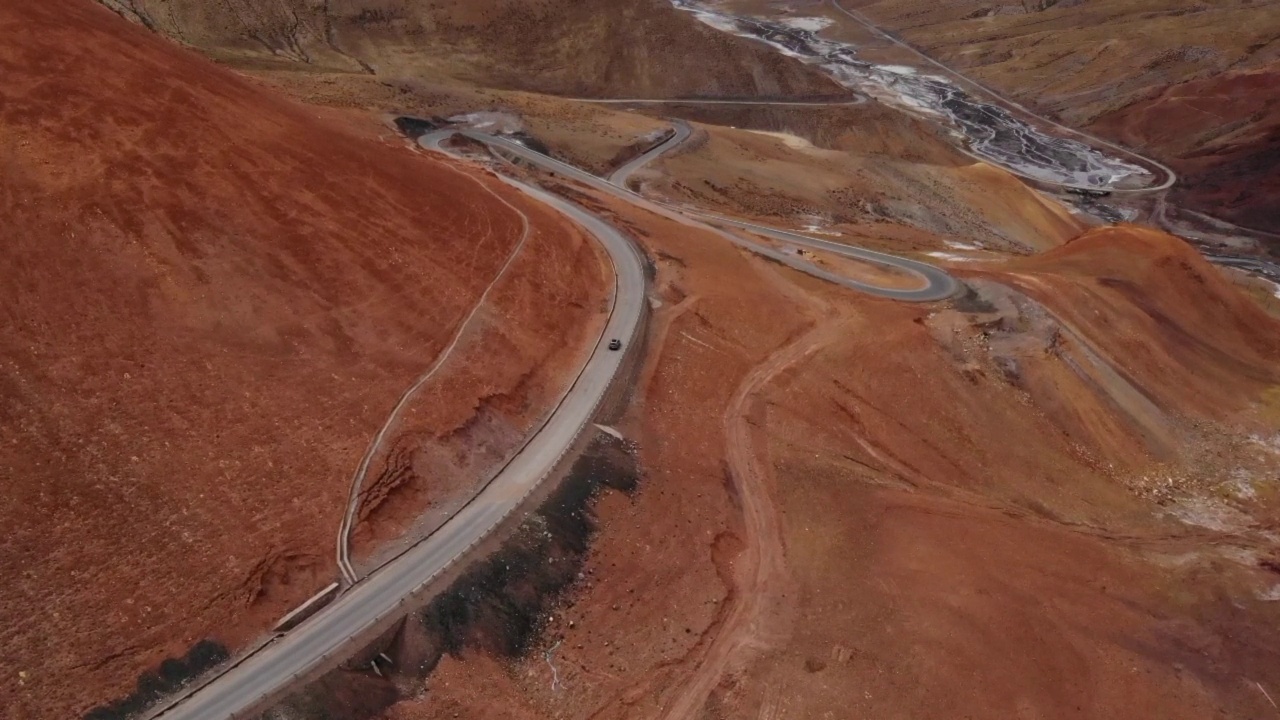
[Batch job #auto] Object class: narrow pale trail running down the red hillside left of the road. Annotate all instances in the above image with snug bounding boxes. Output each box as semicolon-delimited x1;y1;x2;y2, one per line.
338;168;530;584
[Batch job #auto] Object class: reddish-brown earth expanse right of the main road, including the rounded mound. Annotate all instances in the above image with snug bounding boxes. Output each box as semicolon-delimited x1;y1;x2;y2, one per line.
385;205;1280;720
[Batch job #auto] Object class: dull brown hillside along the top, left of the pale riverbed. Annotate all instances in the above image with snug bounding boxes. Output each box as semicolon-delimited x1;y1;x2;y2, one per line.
102;0;841;97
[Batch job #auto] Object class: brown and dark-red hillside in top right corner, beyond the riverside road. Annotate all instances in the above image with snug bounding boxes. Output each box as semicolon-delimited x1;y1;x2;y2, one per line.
841;0;1280;232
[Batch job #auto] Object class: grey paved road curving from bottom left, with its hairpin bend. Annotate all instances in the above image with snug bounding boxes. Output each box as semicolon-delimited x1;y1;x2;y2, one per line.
145;123;957;720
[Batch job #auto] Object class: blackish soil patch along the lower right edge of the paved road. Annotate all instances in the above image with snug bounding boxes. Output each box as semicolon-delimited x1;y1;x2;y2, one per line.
260;433;640;720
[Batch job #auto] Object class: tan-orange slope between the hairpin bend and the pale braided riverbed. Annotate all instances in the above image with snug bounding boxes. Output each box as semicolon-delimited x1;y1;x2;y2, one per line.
639;105;1082;252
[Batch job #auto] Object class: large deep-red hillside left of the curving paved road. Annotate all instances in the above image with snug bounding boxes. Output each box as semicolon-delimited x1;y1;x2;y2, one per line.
0;0;609;720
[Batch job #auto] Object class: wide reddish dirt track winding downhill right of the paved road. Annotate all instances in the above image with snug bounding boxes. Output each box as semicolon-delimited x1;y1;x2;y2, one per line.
658;318;838;720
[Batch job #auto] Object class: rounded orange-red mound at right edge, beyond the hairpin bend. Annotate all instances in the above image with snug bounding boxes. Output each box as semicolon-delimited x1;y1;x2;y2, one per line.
1007;225;1280;416
